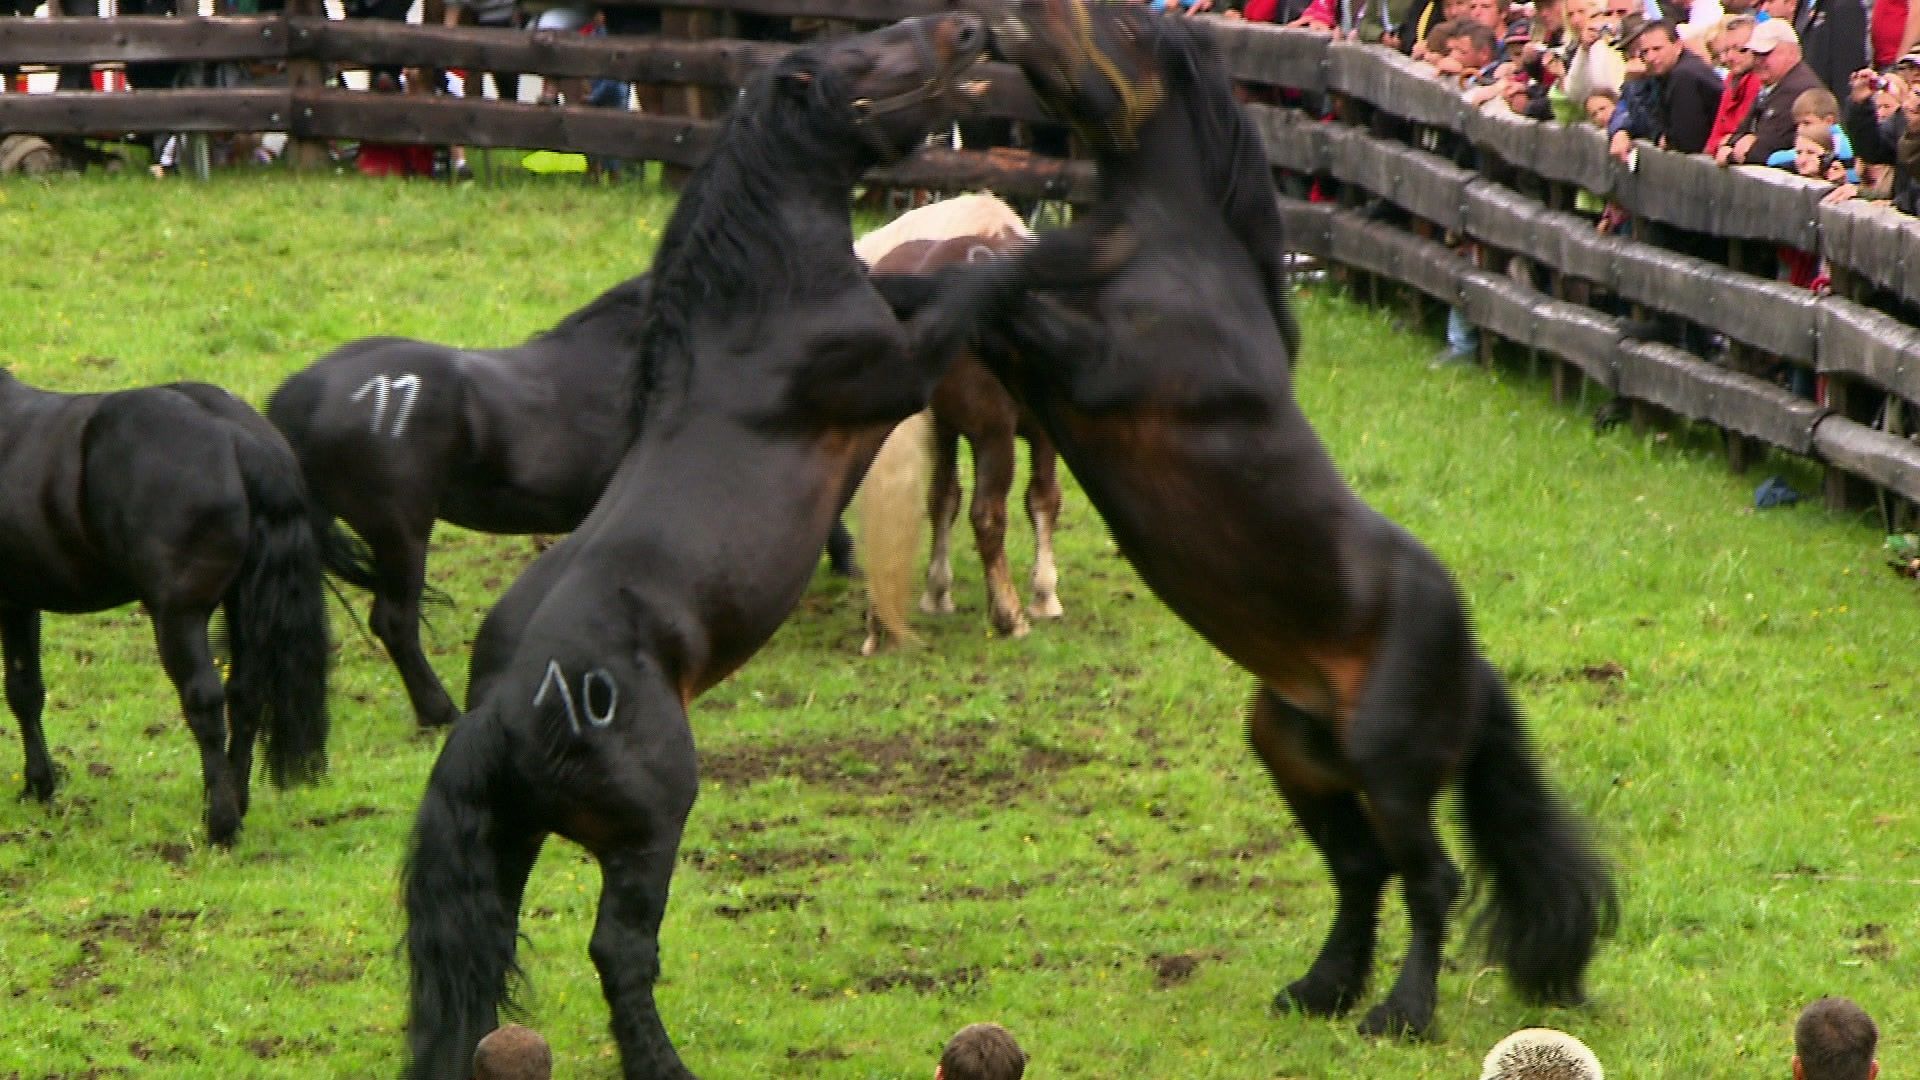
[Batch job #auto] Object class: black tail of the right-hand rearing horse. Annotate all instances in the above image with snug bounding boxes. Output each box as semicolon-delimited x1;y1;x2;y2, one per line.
1461;657;1620;1003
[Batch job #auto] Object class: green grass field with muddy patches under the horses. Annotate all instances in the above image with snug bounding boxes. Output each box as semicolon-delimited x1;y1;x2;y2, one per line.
0;177;1920;1080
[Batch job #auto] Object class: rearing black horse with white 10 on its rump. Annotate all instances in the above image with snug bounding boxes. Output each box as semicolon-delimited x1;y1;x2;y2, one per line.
405;13;1085;1080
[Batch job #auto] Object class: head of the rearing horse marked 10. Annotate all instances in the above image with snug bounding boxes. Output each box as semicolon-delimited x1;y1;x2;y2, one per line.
772;12;989;163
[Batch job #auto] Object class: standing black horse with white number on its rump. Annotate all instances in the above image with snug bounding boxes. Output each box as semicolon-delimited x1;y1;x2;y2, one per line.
267;275;852;726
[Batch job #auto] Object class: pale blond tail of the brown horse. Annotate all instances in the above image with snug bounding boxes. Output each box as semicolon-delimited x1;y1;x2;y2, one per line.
858;409;933;653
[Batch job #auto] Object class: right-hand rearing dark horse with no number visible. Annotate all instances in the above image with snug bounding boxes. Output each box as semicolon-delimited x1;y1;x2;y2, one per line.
960;0;1617;1034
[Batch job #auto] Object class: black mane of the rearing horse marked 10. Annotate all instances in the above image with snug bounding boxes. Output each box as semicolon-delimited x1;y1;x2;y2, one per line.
634;48;851;413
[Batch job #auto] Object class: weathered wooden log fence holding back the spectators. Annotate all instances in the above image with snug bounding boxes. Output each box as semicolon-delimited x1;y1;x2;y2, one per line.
0;12;1920;513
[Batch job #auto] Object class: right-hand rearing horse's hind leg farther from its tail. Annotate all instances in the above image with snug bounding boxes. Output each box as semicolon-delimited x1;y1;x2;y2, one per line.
1246;686;1392;1017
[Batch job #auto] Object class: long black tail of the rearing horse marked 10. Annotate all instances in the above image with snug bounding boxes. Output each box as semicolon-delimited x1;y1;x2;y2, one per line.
401;707;520;1080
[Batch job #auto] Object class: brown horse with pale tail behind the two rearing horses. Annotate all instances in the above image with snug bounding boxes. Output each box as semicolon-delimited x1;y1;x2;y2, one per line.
854;194;1066;651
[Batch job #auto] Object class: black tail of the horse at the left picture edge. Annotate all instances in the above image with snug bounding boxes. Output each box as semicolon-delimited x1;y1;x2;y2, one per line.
225;424;332;788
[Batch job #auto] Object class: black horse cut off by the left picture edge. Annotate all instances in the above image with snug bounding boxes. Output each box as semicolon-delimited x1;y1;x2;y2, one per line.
0;371;328;846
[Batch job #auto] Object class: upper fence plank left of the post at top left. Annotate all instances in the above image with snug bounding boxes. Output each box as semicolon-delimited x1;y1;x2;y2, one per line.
0;15;292;65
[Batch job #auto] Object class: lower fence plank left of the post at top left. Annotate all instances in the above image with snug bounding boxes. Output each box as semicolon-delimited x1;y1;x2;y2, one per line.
0;86;288;136
